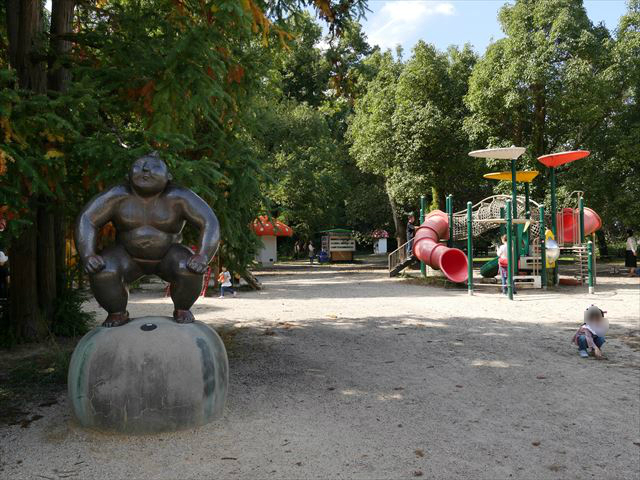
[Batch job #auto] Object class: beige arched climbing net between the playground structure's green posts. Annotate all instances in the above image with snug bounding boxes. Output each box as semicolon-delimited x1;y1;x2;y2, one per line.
453;195;546;240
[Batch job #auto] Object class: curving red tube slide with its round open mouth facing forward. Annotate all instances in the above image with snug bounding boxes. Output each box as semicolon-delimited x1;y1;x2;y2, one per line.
413;210;468;283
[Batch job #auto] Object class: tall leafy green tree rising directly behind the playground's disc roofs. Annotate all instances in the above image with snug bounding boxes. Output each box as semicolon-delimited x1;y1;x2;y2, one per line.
465;0;616;197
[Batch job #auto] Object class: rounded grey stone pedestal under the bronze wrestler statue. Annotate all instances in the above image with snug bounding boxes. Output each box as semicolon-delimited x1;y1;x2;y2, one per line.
68;317;229;434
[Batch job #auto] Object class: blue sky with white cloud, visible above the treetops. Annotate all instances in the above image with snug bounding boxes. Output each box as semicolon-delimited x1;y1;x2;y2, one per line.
361;0;626;55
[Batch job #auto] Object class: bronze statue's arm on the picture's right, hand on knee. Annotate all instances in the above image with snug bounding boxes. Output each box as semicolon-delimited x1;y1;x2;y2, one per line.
177;188;220;263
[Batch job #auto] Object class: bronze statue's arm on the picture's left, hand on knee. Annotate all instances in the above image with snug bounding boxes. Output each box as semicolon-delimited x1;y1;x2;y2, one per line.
75;187;122;266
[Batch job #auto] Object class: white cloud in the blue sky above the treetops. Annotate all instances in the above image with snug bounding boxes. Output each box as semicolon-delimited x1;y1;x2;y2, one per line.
366;0;455;48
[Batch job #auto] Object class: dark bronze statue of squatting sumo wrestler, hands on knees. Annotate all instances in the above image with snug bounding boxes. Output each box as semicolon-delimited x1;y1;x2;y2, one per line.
76;152;220;327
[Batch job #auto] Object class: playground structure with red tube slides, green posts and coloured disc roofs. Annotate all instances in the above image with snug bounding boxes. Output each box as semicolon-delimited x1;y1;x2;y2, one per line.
389;147;602;299
